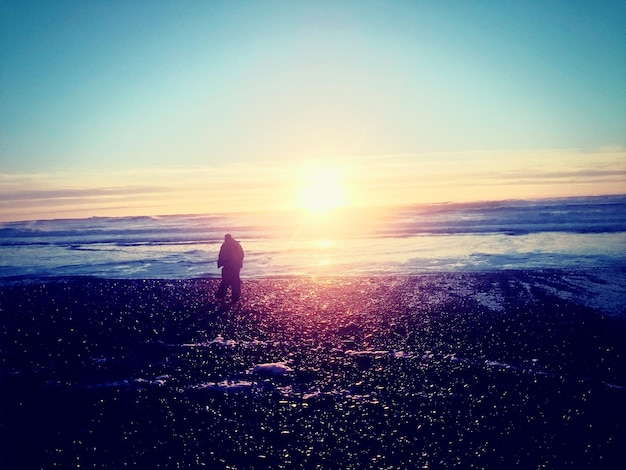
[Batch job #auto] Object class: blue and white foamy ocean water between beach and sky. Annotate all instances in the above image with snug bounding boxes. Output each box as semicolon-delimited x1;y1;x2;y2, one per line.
0;196;626;279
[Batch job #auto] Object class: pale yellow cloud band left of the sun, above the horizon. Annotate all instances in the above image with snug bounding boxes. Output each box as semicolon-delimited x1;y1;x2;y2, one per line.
0;163;298;221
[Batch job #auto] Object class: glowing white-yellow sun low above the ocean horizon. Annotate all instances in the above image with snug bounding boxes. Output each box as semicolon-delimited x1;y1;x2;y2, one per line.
300;168;345;212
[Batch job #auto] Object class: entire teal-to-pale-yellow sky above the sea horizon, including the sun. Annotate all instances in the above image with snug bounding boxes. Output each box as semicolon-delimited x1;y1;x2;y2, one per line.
0;0;626;221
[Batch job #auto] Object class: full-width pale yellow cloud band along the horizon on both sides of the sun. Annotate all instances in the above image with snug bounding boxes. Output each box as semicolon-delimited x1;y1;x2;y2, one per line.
0;149;626;220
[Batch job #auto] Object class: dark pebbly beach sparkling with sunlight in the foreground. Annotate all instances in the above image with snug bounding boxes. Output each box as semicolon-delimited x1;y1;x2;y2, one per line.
0;270;626;470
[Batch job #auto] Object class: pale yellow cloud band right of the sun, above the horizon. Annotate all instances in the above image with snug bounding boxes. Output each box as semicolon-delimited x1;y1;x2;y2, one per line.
342;149;626;204
